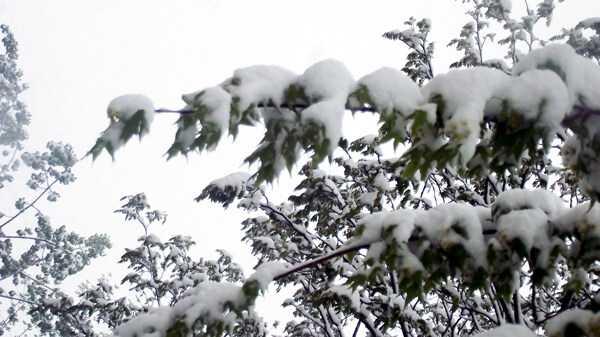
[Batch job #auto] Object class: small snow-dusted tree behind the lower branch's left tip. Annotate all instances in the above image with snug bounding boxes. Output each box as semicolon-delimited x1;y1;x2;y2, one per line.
36;193;266;337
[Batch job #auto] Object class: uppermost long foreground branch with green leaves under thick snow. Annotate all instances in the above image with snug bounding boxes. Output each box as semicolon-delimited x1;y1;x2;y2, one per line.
90;44;600;195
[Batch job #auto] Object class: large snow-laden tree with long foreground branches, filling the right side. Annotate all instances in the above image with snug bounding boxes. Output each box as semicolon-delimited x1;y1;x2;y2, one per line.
90;0;600;337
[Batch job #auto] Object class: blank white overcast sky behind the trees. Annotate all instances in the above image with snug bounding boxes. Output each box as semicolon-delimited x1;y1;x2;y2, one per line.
0;0;600;330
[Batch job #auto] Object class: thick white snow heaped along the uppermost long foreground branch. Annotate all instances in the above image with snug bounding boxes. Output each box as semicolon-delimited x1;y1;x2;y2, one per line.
158;44;600;178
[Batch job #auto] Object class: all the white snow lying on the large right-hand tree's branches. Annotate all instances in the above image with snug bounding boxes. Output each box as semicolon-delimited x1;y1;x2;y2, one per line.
108;44;600;337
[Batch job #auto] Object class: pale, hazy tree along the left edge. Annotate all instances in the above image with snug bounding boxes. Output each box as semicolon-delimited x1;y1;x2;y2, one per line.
0;25;110;336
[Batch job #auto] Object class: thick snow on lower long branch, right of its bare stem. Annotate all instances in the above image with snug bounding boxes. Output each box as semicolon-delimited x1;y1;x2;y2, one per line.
347;189;576;281
